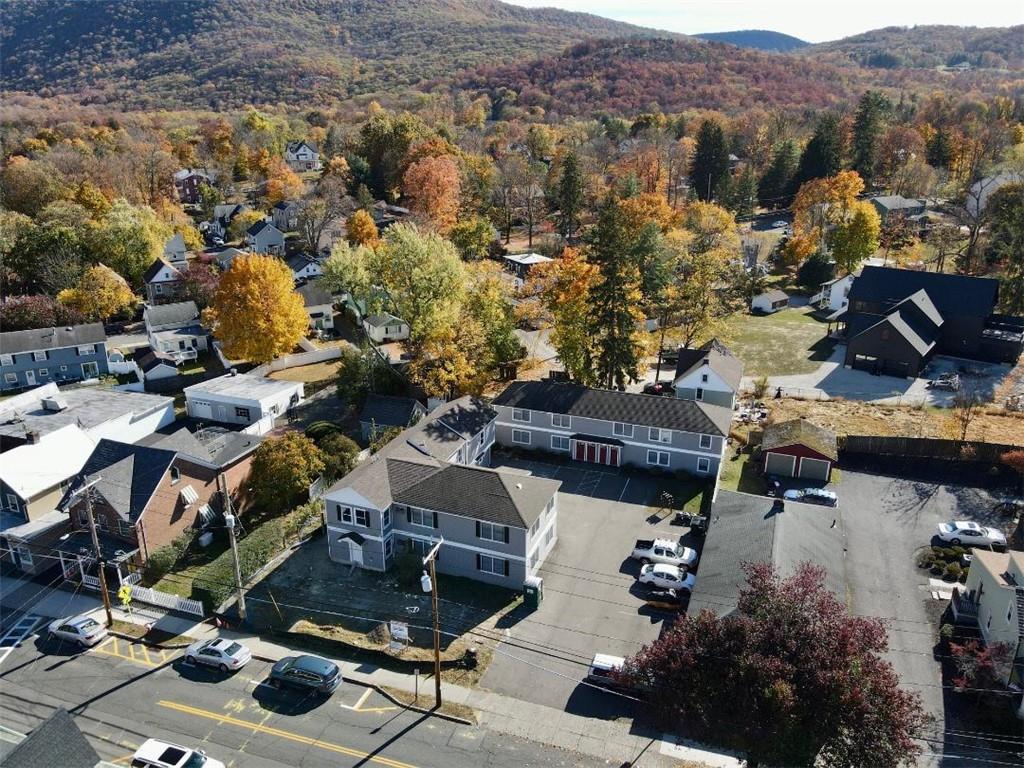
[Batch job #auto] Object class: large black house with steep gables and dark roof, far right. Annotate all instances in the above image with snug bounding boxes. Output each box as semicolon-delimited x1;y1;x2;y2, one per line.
839;266;1024;377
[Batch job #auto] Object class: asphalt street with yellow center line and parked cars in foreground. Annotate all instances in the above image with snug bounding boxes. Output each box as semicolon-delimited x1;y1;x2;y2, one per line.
0;636;603;768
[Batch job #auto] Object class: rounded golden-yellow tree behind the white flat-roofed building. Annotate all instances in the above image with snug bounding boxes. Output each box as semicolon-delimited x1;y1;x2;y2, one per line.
204;254;309;362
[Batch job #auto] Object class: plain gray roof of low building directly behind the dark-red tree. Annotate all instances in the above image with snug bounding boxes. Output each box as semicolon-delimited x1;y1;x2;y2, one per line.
688;490;846;616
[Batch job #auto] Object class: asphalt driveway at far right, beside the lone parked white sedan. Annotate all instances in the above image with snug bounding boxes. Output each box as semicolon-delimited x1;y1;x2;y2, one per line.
837;468;1011;768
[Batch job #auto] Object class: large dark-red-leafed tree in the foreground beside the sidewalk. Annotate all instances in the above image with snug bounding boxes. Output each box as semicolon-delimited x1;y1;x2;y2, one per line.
624;563;929;768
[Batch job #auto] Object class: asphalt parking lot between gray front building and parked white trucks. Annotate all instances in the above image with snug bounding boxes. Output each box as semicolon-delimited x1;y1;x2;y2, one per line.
481;457;696;718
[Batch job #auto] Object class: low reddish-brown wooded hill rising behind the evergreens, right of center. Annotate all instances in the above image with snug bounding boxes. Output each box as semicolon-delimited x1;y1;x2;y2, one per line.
458;39;1020;116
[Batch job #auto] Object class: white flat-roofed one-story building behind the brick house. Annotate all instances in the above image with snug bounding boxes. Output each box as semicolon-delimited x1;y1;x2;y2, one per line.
184;373;304;434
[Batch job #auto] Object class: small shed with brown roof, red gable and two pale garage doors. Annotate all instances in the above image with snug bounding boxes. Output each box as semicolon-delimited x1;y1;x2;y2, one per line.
761;419;839;482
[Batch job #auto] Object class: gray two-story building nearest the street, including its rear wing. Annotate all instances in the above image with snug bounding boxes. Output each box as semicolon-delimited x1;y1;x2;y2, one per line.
325;397;559;589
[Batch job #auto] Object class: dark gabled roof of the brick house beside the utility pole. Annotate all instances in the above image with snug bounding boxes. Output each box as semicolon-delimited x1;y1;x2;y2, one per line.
57;438;176;523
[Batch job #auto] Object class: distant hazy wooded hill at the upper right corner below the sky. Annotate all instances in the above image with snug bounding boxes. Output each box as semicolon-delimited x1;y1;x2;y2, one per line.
804;26;1024;70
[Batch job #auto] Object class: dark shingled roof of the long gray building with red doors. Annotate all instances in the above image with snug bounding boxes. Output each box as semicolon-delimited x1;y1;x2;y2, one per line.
494;381;732;435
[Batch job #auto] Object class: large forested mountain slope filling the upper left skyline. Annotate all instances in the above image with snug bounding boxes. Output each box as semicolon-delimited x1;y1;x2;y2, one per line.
0;0;655;110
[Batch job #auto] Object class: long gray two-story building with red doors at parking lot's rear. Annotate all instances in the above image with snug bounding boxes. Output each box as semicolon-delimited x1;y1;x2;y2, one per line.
492;381;732;477
